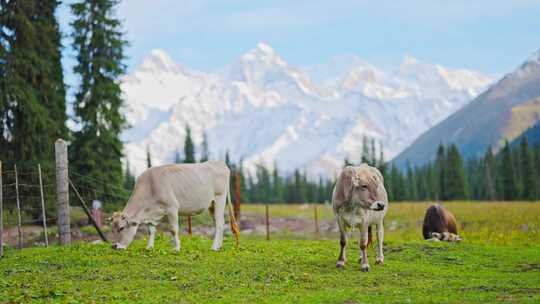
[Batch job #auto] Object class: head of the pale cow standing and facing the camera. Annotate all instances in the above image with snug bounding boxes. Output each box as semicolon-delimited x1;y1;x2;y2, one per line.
351;164;387;211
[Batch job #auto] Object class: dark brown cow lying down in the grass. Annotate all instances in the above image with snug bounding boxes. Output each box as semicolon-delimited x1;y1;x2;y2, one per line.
422;204;461;242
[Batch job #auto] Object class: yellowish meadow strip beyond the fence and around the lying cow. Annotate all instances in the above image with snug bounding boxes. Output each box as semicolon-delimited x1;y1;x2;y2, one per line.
242;202;540;245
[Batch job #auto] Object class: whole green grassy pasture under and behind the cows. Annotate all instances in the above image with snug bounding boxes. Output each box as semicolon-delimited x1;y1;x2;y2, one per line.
0;202;540;303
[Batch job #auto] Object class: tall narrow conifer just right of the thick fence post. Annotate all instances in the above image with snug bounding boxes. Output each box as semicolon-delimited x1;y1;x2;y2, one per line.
70;0;127;202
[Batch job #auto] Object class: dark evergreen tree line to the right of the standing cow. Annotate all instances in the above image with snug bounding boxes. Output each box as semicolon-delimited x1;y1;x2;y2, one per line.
382;137;540;201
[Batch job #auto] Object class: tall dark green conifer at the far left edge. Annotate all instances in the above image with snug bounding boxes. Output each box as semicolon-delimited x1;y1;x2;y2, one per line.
0;0;68;168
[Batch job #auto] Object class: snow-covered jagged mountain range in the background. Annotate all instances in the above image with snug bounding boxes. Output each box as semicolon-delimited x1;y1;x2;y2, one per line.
122;43;493;177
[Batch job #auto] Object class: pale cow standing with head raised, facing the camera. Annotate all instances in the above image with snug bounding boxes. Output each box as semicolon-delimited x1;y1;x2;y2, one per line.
332;164;388;271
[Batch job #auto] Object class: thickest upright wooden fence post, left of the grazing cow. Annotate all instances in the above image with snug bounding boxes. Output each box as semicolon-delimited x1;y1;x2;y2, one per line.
54;139;71;245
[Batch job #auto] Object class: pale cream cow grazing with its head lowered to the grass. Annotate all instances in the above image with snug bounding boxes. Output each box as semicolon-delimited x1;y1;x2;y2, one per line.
112;161;239;251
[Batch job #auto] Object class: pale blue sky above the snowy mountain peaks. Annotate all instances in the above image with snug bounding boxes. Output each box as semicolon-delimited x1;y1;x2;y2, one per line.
58;0;540;76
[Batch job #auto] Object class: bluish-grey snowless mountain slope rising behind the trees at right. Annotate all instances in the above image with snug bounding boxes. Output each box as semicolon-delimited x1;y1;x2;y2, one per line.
394;50;540;167
